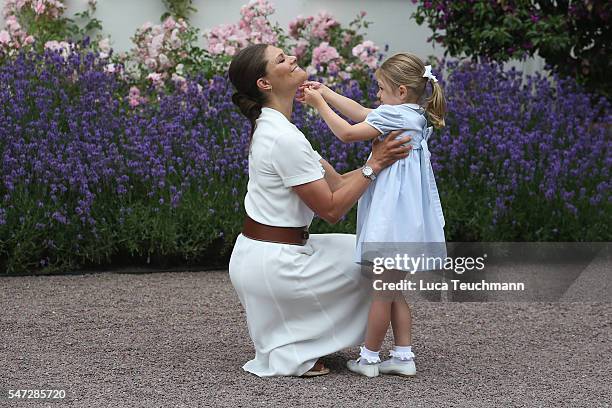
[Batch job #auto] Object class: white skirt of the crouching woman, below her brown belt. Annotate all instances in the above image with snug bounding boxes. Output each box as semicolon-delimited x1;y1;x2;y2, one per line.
229;234;371;377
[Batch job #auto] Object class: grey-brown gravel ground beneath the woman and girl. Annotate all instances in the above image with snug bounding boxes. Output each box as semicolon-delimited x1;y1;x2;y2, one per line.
0;271;612;408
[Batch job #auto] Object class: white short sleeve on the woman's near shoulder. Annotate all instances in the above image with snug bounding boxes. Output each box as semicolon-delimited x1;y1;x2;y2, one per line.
270;134;323;187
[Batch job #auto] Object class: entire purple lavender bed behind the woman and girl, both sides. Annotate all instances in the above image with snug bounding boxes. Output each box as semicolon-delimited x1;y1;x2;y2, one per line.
0;50;612;272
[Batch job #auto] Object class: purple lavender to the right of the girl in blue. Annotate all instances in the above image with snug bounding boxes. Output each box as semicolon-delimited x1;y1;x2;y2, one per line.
431;62;612;241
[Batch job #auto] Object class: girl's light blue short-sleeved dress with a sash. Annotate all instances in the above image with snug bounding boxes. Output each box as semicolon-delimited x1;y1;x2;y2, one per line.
355;104;446;269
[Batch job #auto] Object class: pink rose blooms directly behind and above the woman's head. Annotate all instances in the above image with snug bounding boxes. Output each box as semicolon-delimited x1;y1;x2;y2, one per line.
206;0;382;86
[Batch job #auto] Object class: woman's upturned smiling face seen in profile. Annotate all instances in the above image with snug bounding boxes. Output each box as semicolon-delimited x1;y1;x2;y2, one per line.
264;45;308;94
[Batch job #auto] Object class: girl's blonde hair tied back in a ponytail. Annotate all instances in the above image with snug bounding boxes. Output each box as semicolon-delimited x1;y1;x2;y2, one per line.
376;53;446;128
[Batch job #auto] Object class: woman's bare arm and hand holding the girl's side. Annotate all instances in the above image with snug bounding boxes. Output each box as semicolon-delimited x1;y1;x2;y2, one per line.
293;132;411;224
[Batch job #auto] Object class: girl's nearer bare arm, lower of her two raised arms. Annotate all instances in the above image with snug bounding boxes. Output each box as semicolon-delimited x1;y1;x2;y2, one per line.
304;88;381;143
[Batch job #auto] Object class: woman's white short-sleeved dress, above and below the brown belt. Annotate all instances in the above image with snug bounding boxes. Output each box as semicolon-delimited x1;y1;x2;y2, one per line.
229;108;370;377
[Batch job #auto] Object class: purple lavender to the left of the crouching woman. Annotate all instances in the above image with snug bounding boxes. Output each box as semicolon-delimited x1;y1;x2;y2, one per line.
0;46;248;272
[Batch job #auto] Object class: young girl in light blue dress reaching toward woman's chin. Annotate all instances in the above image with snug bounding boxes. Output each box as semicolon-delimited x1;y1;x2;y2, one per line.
300;54;446;377
